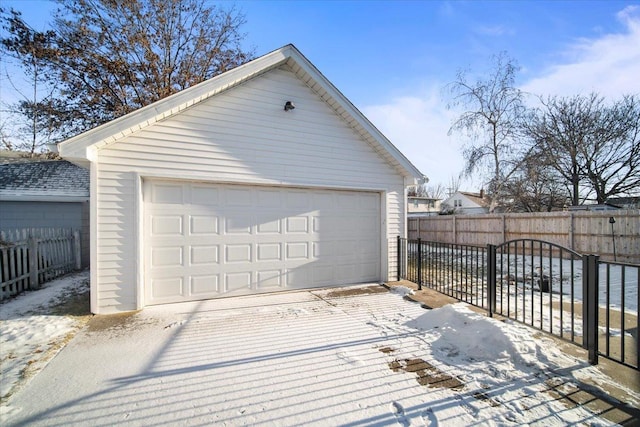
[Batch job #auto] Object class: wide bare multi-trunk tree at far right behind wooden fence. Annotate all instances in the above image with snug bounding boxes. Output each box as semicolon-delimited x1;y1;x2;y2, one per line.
526;93;640;206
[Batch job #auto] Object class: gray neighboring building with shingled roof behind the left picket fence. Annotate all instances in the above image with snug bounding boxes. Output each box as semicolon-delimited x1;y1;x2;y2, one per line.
0;153;90;266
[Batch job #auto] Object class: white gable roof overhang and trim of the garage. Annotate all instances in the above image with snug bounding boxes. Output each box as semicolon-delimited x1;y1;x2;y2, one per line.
58;44;423;183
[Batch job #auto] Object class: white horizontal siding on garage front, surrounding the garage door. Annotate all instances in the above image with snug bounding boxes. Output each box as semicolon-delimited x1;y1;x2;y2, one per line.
93;68;405;313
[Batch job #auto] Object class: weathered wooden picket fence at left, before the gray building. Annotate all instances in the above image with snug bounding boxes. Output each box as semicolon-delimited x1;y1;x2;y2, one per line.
0;229;81;300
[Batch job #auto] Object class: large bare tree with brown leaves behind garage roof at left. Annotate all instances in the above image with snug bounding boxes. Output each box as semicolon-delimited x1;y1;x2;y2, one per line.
0;0;252;140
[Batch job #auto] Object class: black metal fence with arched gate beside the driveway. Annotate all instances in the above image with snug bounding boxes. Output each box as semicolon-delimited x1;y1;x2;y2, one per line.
398;237;640;369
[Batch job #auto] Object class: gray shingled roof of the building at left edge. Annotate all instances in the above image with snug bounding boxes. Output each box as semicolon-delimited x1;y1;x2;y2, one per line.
0;160;89;200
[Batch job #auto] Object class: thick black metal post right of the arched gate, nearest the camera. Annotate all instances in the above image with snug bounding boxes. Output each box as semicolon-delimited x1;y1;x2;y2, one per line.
582;255;600;365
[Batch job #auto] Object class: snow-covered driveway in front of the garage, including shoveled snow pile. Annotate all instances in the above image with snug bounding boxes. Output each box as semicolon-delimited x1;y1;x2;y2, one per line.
2;286;637;426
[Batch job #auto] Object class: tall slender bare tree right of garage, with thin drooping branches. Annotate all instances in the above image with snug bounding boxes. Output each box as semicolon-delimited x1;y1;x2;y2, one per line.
448;53;526;212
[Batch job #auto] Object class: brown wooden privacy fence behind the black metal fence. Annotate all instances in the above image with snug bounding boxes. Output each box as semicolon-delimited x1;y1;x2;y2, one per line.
408;209;640;264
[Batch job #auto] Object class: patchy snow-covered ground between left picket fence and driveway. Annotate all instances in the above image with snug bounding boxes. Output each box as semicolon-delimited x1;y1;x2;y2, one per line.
0;271;89;399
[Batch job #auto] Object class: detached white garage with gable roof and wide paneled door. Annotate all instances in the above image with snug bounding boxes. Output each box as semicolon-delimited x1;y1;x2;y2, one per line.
58;45;423;313
